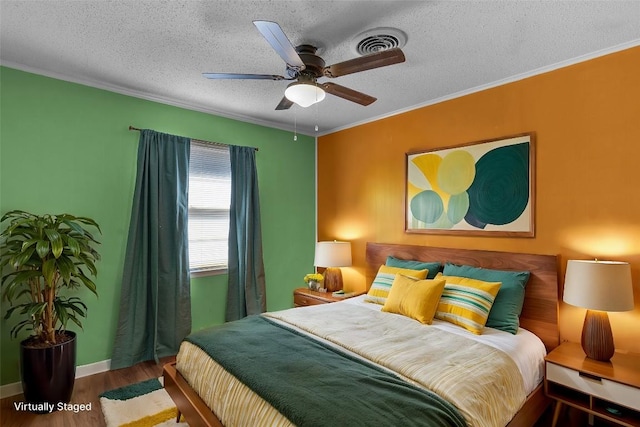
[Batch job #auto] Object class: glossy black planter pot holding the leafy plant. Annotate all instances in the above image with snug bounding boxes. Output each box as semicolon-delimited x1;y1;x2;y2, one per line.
20;331;76;407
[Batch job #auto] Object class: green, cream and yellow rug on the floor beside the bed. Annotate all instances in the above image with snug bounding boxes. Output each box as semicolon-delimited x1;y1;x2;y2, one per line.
100;377;187;427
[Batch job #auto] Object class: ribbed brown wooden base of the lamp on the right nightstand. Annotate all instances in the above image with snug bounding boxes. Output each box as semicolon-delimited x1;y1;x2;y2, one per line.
582;310;615;362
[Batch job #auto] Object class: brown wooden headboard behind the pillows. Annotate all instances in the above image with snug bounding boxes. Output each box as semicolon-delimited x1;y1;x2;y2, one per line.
366;242;560;351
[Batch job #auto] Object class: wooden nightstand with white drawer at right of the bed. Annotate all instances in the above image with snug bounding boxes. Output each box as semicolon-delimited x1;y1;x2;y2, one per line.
544;342;640;427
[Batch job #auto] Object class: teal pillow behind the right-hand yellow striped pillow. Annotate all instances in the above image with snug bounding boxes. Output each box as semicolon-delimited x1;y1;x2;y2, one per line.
442;263;529;335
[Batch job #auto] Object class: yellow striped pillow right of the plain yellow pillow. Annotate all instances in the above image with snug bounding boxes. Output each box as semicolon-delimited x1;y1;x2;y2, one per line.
435;273;502;335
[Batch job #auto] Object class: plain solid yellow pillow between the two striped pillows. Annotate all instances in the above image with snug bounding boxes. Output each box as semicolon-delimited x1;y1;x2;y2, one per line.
382;274;445;325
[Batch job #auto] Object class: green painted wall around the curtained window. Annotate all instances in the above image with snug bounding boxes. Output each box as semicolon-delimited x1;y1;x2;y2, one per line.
0;67;315;385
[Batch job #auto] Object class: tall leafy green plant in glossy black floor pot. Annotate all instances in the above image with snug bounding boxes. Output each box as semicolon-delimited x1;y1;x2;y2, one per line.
0;210;101;412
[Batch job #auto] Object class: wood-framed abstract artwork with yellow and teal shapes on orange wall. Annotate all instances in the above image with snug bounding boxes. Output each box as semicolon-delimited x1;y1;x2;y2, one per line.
405;132;535;237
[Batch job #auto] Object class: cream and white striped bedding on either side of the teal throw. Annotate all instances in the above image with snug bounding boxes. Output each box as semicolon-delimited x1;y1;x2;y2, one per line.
177;297;545;427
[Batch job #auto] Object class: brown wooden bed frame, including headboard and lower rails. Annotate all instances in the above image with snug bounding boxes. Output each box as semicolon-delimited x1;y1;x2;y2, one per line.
163;243;560;427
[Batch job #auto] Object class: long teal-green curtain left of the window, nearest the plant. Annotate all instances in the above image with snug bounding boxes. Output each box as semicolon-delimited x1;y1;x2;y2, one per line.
111;129;191;369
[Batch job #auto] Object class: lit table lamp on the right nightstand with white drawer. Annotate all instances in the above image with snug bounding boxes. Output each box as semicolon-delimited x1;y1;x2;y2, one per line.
562;260;633;362
